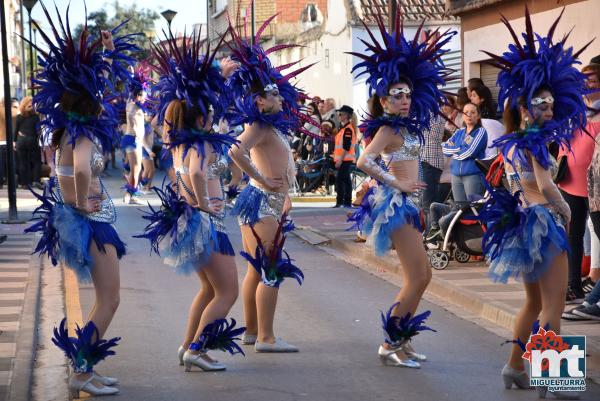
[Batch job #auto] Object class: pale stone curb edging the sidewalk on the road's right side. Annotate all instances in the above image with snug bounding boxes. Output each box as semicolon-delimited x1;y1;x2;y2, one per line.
292;226;600;384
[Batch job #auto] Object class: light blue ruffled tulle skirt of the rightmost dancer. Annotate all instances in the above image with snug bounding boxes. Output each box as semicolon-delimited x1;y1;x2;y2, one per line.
488;205;569;283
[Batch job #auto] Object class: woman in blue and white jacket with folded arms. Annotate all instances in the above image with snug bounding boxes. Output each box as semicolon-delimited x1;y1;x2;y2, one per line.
442;103;487;202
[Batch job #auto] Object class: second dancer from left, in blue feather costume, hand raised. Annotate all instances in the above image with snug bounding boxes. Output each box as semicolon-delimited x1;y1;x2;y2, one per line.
141;28;244;371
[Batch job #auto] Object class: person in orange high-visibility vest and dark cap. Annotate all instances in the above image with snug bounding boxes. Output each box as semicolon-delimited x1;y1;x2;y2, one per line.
333;105;356;207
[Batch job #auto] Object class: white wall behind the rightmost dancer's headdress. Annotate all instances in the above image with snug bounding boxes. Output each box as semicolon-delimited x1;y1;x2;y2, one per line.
463;0;600;82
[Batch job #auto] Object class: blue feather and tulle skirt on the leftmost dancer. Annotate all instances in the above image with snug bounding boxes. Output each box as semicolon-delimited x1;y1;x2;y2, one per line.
31;203;126;283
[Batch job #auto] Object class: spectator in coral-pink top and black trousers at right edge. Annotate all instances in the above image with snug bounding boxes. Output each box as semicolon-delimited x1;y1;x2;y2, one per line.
558;61;600;304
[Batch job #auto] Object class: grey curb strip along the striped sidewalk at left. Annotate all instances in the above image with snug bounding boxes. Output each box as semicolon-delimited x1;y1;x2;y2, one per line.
8;236;42;401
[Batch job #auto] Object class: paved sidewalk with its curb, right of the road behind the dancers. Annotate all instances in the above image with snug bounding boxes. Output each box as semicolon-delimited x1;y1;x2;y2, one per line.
294;211;600;373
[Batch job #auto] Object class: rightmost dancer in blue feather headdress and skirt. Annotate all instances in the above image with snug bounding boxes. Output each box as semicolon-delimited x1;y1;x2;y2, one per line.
479;8;587;398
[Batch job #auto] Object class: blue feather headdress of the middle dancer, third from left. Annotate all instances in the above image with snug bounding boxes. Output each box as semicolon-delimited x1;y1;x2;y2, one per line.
226;9;320;138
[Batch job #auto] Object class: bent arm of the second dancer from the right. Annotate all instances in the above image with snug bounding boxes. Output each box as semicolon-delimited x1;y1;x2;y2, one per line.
356;127;426;193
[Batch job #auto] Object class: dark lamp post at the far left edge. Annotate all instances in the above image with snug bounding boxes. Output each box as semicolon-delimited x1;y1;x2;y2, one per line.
0;1;19;223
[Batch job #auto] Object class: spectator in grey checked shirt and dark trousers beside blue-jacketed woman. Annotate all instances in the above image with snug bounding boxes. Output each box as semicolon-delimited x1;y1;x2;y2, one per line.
420;116;446;227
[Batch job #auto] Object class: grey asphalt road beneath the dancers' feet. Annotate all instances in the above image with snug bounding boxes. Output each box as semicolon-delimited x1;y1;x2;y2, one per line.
70;176;600;401
